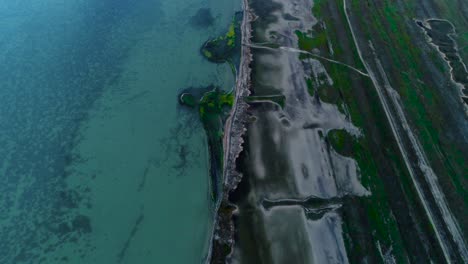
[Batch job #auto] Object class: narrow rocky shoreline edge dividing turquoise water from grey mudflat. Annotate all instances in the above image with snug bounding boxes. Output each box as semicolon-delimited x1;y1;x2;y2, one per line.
206;0;254;263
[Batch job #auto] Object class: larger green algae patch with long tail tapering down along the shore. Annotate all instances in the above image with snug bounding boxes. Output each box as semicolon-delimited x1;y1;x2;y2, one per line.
179;86;234;201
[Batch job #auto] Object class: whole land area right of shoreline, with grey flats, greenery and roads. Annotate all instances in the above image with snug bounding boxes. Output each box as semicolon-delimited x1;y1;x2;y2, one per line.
213;0;468;263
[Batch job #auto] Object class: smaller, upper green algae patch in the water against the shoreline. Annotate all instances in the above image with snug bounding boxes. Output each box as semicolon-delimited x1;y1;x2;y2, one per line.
201;16;241;63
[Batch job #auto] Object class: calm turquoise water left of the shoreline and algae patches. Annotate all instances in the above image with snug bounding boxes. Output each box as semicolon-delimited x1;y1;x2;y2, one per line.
0;0;240;263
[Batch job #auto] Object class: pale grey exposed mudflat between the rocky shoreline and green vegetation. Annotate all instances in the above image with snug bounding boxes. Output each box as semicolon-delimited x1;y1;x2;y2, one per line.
223;1;370;263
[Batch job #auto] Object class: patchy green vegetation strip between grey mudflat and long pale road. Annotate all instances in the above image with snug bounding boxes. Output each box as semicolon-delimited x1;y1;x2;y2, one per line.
296;0;416;263
